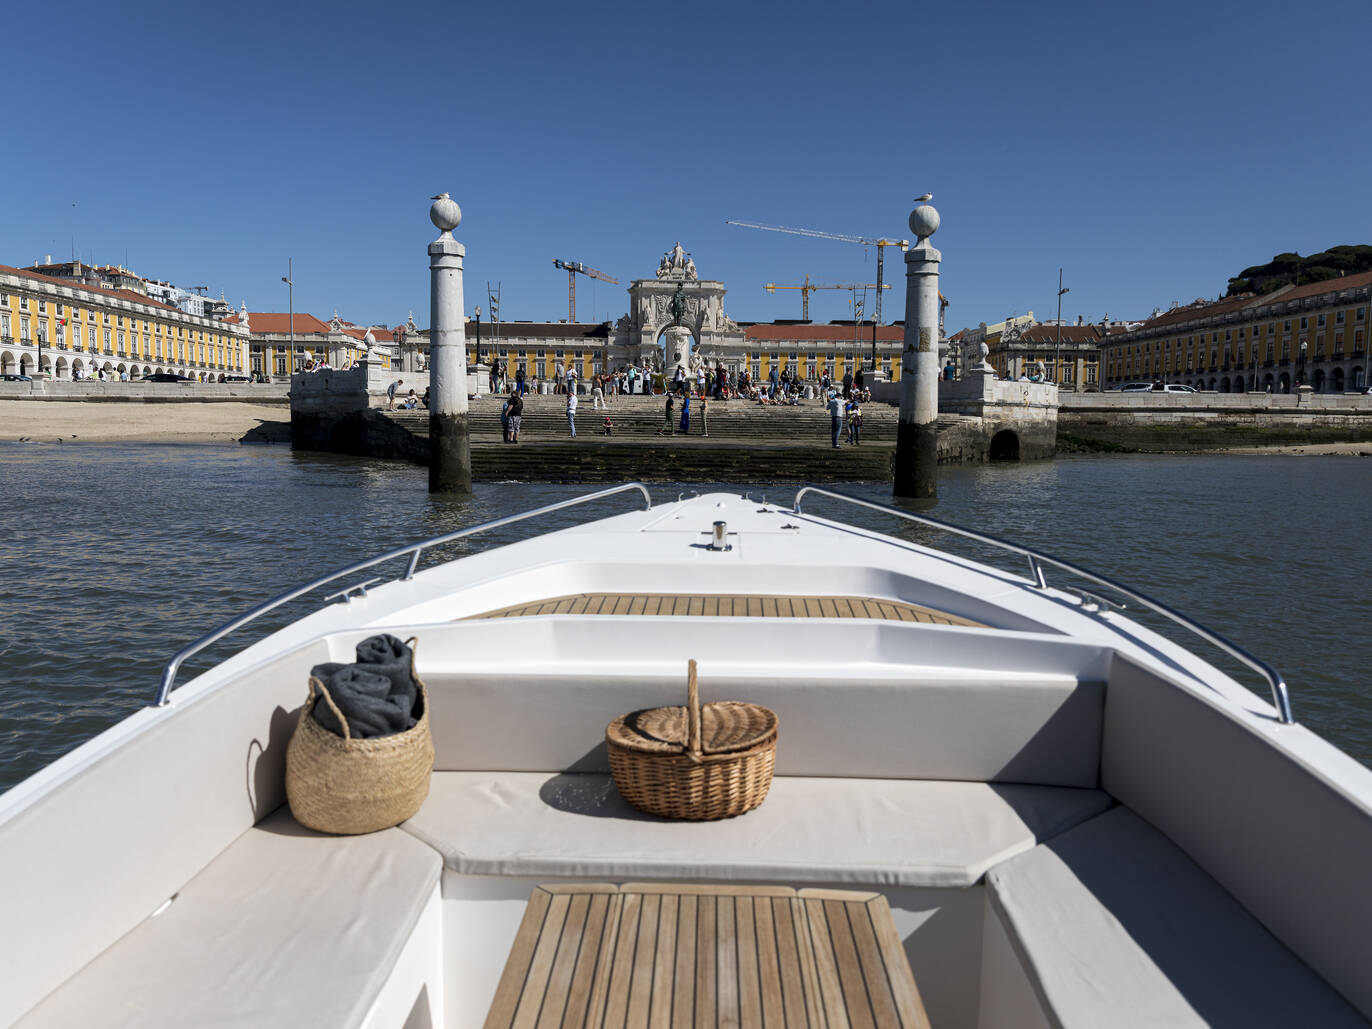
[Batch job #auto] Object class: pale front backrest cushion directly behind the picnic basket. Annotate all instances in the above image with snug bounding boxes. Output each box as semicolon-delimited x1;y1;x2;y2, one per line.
421;668;1103;788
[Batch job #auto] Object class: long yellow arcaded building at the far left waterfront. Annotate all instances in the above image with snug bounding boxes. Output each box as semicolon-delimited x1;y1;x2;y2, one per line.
0;265;248;381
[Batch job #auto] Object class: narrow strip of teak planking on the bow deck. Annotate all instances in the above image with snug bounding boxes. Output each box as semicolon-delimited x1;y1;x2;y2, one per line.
464;593;984;628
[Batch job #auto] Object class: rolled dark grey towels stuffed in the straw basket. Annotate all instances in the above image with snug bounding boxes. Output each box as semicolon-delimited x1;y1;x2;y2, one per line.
310;634;418;740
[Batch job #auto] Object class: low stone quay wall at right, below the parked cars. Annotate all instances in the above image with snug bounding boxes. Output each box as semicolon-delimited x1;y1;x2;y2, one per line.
1058;392;1372;451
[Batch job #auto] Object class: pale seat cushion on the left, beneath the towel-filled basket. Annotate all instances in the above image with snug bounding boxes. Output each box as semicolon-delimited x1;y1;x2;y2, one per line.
19;808;442;1029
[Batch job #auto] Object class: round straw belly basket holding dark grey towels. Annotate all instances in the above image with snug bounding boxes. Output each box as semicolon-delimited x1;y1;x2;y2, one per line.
285;641;434;836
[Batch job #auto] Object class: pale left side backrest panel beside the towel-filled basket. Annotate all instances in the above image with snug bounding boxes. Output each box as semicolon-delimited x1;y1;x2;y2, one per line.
0;641;328;1025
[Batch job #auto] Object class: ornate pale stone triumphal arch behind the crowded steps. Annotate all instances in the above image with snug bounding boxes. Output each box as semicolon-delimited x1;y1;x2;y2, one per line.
613;241;745;375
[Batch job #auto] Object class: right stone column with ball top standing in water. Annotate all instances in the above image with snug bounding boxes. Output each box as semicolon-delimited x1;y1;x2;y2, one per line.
895;204;943;497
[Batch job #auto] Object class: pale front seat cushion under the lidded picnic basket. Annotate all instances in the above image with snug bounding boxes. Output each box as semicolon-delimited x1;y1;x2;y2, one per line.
402;771;1113;888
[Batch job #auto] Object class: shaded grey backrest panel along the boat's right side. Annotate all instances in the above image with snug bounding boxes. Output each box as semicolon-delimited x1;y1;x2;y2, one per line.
1100;656;1372;1018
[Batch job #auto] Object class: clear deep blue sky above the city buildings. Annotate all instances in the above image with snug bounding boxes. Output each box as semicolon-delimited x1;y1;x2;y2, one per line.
0;0;1372;331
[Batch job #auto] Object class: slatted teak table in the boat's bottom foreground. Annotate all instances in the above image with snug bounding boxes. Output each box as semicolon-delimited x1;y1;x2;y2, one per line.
486;884;929;1029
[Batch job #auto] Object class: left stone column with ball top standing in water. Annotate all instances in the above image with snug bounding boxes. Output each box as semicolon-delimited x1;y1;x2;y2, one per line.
429;193;472;493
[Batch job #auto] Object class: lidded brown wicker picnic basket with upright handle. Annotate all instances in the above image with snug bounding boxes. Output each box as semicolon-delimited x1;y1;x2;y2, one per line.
605;660;777;820
